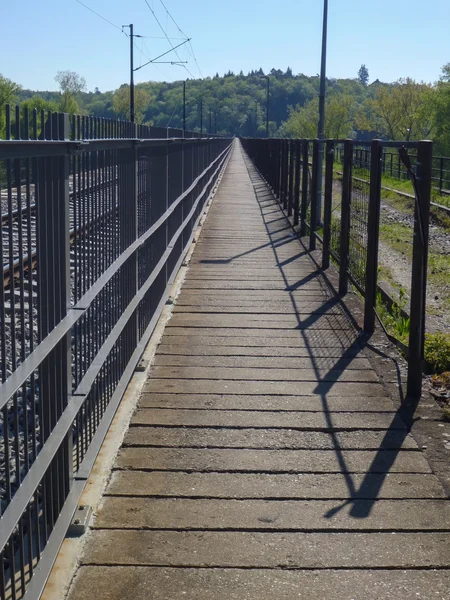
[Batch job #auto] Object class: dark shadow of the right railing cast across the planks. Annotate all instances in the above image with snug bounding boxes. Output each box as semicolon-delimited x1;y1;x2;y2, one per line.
246;159;418;519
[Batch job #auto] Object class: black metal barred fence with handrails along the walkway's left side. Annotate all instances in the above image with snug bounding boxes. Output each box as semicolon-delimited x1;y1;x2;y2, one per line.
0;105;231;600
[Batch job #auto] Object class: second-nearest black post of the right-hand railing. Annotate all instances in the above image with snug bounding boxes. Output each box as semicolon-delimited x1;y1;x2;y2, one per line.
364;140;383;333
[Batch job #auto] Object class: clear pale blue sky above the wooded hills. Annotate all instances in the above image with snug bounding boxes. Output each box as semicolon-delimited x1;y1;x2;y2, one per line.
0;0;450;91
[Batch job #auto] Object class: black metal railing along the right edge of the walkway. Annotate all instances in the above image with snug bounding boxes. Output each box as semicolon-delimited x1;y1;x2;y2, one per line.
242;139;433;398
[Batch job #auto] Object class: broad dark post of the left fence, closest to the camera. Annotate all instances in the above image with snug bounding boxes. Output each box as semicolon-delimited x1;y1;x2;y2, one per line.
35;113;73;529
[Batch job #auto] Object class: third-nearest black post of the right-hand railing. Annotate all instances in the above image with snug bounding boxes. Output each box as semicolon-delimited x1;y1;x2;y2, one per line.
339;140;352;295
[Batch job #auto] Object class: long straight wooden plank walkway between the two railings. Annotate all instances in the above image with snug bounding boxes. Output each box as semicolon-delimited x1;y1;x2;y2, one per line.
70;142;450;600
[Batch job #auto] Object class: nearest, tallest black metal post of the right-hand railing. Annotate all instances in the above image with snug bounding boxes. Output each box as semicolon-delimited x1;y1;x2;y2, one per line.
407;141;433;399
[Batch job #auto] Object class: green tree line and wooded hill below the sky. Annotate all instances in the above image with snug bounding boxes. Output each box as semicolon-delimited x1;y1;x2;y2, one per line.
0;63;450;155
